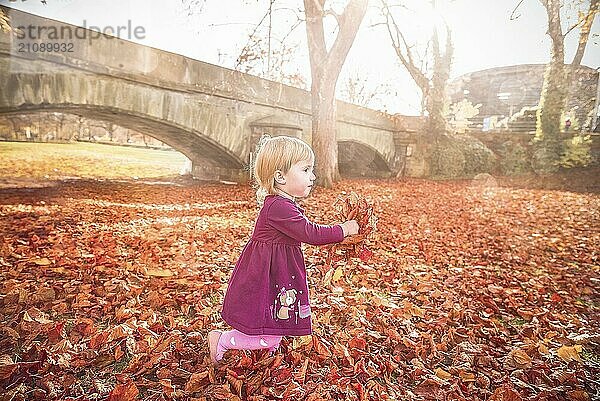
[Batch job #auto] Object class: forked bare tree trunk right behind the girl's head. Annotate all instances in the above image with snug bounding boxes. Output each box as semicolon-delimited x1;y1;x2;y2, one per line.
304;0;368;187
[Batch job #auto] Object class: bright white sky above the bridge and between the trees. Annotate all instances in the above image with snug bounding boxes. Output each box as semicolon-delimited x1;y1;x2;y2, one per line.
0;0;600;115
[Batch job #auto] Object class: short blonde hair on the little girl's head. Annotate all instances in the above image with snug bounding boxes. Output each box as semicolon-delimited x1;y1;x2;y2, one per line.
252;135;315;203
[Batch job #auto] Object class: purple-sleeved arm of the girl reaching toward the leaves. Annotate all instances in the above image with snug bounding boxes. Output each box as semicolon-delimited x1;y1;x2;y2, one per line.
267;200;344;245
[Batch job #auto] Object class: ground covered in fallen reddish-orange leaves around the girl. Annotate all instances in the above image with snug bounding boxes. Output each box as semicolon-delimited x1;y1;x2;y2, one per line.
0;155;600;401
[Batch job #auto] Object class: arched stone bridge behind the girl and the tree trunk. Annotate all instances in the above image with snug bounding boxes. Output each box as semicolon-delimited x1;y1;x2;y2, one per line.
0;8;419;181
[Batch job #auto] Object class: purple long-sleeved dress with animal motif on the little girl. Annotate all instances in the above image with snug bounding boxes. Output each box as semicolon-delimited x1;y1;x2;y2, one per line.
221;195;344;336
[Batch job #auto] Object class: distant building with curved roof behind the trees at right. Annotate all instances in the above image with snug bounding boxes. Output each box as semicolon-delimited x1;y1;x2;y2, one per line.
449;64;598;131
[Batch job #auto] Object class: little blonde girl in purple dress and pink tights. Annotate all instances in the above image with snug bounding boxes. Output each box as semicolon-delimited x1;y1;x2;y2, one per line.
208;136;358;363
